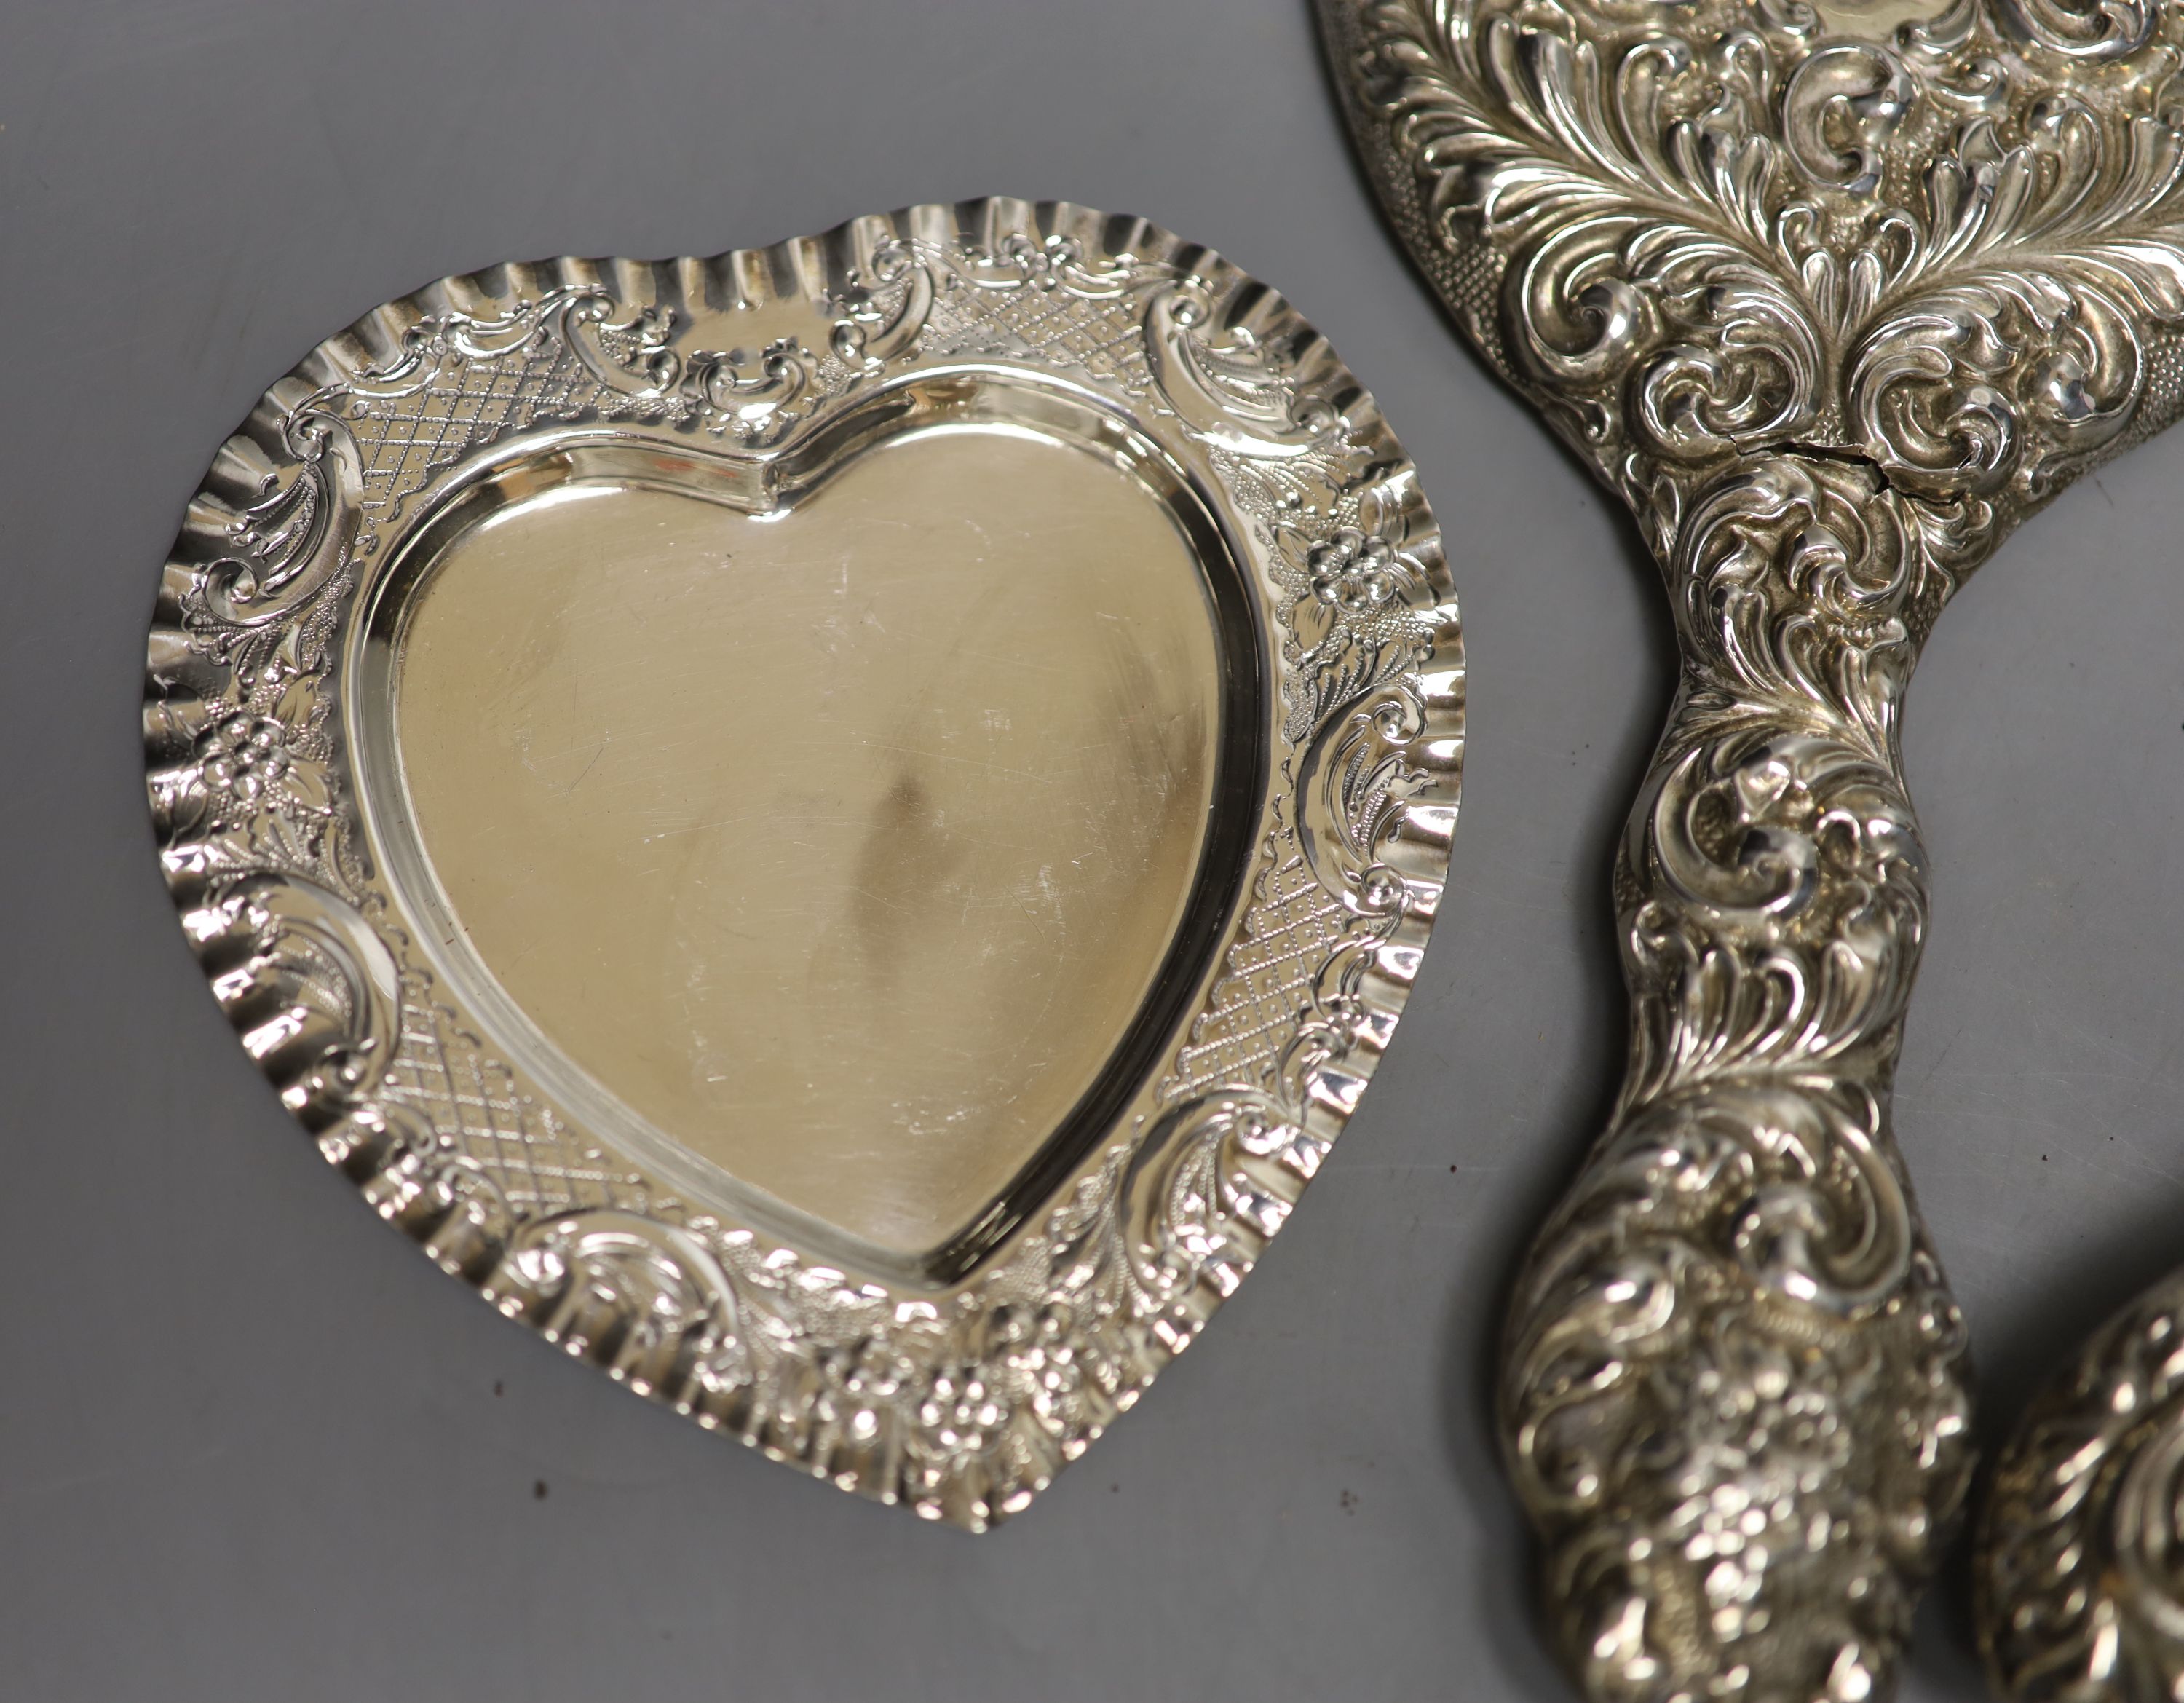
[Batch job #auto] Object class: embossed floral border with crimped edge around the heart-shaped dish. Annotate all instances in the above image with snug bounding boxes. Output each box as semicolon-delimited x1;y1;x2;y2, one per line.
144;201;1463;1530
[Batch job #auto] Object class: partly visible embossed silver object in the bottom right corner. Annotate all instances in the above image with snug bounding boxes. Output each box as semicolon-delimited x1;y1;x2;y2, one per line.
1974;1271;2184;1703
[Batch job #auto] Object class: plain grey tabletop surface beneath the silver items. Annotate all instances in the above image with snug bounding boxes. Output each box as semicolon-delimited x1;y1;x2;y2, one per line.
0;0;2184;1703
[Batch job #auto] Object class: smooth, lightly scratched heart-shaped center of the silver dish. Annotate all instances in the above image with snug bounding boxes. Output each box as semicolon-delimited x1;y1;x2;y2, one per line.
395;428;1221;1257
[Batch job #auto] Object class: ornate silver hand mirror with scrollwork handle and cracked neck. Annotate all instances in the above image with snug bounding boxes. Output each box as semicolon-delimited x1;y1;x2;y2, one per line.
1321;0;2184;1701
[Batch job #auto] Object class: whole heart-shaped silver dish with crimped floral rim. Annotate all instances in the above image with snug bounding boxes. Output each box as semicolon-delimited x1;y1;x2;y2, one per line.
146;201;1463;1528
